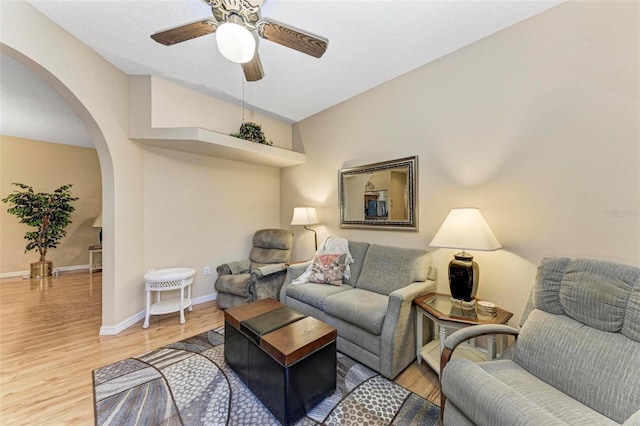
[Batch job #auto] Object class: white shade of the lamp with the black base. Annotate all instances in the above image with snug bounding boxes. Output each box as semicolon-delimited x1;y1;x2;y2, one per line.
429;208;502;251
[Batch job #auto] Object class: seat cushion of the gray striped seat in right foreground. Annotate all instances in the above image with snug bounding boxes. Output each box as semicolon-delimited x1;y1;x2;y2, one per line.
442;359;616;426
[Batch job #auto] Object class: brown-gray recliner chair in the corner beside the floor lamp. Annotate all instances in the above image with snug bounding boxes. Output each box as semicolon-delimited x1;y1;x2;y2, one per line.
215;229;293;309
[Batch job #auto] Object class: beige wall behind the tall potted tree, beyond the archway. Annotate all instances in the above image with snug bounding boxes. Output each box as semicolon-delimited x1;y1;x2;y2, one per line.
0;136;102;274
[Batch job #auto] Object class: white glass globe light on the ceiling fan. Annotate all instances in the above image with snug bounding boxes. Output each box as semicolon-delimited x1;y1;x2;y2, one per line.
216;15;256;64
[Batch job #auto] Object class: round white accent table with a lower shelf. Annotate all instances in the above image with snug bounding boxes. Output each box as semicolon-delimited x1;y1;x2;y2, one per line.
142;268;196;328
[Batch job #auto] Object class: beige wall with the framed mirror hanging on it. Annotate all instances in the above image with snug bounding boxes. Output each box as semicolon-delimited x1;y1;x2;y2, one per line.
281;1;640;322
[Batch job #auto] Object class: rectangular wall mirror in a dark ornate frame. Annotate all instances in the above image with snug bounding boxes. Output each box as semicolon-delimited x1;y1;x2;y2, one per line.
338;156;418;231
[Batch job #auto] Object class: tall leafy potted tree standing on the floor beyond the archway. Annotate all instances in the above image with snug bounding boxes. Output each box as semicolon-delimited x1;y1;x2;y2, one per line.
2;183;78;278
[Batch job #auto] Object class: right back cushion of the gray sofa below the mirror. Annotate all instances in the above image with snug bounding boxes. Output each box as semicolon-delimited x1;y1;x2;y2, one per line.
356;244;430;296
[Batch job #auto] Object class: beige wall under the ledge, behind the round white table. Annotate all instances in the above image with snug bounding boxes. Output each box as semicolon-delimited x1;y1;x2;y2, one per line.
144;148;280;297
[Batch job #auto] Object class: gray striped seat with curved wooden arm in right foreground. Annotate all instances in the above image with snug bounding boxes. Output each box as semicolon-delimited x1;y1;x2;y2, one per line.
441;258;640;426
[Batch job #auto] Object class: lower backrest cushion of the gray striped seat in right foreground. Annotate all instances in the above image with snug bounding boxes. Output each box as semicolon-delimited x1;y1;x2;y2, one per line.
516;309;640;423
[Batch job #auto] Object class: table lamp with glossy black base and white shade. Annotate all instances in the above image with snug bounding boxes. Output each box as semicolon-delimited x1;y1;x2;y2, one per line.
429;208;502;309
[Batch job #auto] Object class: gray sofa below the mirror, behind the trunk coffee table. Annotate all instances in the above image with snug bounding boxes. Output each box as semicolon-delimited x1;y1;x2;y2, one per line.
280;241;436;379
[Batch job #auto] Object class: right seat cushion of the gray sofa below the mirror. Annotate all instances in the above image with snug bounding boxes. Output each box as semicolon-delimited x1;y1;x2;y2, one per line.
324;288;389;335
